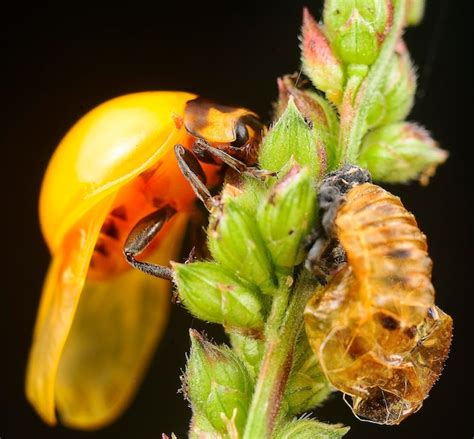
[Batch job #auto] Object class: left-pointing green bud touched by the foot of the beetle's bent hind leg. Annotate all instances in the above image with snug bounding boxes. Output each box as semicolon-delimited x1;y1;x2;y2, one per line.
173;262;263;328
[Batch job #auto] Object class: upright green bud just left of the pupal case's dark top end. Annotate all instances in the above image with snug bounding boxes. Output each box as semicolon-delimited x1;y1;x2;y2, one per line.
257;166;316;268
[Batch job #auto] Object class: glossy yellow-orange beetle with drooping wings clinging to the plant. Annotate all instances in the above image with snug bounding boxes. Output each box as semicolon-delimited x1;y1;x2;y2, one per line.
26;92;262;429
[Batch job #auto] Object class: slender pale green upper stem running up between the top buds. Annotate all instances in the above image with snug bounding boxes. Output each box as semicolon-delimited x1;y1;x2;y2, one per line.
339;0;406;166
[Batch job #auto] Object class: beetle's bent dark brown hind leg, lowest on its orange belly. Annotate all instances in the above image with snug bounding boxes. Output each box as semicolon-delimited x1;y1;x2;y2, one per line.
123;205;176;280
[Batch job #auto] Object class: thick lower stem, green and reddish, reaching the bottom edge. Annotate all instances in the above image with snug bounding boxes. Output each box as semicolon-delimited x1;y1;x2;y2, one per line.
243;275;315;439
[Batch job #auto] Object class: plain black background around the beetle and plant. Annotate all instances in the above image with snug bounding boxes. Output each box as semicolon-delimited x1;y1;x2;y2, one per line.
0;0;473;439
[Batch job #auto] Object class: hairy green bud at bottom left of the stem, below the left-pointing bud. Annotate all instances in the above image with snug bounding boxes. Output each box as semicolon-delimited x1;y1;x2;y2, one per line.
185;330;253;433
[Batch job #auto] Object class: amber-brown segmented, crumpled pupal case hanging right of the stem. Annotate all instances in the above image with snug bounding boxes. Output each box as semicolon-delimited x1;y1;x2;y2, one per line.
305;183;452;424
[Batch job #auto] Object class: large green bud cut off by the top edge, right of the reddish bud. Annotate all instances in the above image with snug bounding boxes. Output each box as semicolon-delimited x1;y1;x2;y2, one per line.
323;0;392;65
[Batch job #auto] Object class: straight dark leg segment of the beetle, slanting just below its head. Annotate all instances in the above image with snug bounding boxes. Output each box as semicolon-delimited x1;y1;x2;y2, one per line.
174;145;217;211
